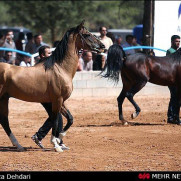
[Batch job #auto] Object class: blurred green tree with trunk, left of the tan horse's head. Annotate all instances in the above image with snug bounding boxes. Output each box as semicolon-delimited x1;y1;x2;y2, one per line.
6;1;96;42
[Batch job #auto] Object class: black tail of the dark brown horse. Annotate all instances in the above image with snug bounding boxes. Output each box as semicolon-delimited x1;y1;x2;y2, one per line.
100;44;126;83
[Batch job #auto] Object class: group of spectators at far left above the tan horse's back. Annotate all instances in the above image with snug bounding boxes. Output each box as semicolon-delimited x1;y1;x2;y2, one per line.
0;30;48;67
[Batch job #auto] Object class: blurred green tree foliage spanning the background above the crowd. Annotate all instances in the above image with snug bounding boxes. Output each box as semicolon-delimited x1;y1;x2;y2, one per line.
0;0;143;45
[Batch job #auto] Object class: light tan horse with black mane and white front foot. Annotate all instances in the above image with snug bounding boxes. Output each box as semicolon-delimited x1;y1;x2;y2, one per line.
0;22;104;152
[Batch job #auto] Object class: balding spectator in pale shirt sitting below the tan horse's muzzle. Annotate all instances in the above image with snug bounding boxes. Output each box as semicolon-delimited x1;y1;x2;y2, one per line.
79;51;93;71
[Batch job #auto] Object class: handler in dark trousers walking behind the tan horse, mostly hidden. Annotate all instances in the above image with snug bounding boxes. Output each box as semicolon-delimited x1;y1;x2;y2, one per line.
31;45;69;150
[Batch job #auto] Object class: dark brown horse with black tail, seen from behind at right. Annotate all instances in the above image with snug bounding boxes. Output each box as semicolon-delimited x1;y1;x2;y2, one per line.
101;44;181;125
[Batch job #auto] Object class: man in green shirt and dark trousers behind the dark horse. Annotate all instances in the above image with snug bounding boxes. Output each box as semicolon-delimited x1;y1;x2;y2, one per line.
166;35;181;125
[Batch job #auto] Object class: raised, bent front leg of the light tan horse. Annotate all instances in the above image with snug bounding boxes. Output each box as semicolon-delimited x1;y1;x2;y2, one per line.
60;104;73;138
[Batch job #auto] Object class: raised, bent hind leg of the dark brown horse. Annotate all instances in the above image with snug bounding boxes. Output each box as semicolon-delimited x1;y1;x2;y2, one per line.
126;81;147;119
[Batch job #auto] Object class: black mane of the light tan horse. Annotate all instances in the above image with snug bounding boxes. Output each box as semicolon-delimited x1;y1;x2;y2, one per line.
39;28;76;70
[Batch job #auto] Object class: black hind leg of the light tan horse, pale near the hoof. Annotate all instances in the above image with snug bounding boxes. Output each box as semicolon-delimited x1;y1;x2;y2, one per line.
0;96;25;151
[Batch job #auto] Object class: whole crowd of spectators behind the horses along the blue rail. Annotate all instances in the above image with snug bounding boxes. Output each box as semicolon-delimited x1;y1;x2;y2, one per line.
0;26;141;71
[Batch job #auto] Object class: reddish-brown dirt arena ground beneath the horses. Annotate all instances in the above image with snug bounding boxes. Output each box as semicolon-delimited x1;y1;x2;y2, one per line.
0;96;181;171
